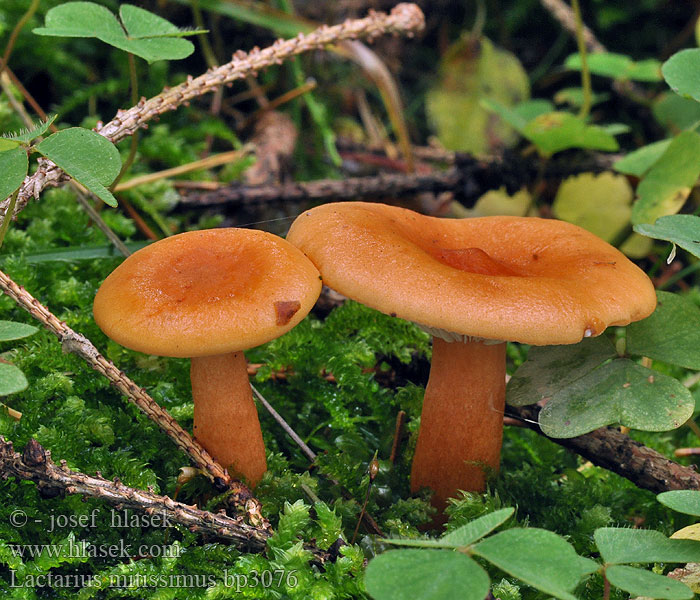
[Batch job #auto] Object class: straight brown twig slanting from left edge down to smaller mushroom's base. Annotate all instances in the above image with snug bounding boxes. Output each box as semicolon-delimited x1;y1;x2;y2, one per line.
0;271;245;497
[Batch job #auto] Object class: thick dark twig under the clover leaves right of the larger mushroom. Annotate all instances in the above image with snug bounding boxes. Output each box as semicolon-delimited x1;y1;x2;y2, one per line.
506;406;700;493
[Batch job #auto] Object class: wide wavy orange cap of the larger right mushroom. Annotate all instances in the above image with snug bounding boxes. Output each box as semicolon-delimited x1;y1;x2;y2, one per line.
287;202;656;345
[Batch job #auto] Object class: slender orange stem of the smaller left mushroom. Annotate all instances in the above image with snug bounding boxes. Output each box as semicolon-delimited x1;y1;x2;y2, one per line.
190;352;267;487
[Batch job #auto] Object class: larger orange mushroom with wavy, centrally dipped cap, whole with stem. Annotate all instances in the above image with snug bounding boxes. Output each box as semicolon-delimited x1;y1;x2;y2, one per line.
287;202;656;509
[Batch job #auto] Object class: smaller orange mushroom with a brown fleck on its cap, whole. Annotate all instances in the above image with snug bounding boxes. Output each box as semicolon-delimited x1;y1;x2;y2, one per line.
93;229;321;486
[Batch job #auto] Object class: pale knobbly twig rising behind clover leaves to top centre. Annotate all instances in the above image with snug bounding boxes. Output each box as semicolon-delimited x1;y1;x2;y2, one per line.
0;4;424;223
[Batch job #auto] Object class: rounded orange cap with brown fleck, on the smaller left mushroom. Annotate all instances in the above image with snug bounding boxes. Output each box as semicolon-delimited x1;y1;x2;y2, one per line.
93;228;321;358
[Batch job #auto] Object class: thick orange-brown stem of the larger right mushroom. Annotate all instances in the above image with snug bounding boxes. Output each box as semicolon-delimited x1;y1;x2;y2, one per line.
411;337;506;511
